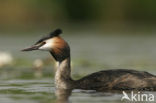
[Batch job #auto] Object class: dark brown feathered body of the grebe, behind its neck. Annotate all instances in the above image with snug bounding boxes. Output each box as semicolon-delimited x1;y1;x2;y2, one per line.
75;69;156;91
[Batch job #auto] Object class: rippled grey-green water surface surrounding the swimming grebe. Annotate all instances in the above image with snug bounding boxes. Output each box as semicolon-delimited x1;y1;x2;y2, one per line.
0;33;156;103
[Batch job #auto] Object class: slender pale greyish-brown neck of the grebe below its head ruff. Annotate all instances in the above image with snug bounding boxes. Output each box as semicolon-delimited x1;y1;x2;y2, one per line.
55;56;73;89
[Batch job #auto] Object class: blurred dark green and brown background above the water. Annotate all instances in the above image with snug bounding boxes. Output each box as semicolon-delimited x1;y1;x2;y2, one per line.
0;0;156;33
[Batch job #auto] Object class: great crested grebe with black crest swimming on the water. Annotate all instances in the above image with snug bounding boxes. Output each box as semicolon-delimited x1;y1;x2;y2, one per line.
22;29;156;91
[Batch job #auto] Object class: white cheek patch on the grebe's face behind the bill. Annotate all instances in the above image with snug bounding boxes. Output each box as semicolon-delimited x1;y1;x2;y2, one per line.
39;39;54;51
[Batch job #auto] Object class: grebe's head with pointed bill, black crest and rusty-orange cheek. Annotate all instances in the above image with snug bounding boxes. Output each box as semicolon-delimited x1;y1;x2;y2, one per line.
22;29;70;61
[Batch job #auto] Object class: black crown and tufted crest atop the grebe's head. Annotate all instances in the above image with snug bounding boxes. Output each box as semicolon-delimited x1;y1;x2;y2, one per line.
35;29;62;44
